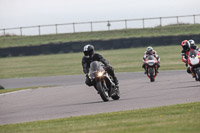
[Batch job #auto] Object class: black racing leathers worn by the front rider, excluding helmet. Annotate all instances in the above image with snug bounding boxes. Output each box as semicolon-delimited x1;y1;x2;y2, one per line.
82;53;118;86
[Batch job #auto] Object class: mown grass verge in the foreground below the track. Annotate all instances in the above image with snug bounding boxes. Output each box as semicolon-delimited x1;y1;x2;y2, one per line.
0;102;200;133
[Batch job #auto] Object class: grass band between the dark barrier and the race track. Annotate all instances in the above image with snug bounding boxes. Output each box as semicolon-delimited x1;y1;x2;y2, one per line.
0;46;188;79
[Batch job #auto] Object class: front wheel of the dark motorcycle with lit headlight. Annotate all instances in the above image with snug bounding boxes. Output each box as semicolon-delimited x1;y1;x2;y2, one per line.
96;80;109;102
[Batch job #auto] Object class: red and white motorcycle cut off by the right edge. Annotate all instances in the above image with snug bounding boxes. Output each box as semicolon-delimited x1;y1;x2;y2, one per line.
188;50;200;81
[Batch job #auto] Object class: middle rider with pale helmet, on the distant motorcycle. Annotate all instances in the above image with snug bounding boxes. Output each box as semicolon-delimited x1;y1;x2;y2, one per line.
142;46;160;74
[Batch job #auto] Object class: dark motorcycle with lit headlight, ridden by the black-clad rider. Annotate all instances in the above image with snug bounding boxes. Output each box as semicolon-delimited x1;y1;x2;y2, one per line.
88;61;120;102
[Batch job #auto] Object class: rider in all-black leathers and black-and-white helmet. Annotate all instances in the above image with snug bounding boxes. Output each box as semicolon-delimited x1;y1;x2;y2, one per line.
82;44;119;86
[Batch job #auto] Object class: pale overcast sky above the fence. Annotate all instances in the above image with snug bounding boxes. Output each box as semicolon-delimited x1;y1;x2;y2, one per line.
0;0;200;29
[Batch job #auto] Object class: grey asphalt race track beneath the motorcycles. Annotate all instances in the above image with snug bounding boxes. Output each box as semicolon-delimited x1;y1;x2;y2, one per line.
0;71;200;125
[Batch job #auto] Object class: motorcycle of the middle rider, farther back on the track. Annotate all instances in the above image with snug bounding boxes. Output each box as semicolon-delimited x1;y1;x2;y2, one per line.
145;55;158;82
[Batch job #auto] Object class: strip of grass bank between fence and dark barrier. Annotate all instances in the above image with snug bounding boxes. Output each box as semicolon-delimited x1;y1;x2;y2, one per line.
0;24;200;48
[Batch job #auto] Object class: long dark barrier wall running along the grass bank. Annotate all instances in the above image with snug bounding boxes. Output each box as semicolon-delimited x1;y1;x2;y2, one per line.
0;34;200;57
